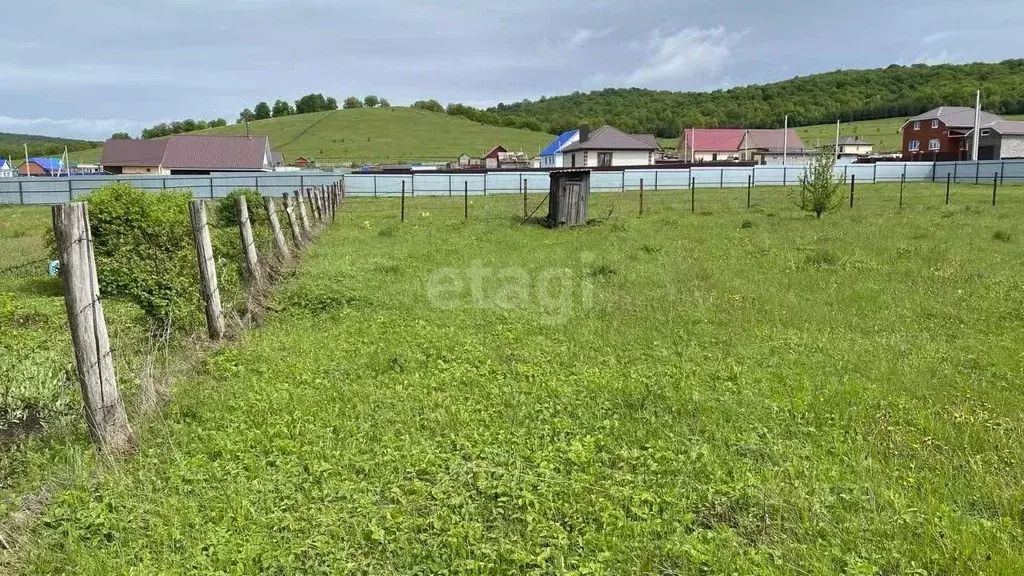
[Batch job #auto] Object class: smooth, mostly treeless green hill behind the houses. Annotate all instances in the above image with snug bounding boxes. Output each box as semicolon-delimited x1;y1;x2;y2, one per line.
72;108;554;164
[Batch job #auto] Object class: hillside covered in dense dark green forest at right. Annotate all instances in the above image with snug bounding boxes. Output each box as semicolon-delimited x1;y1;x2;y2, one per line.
473;59;1024;137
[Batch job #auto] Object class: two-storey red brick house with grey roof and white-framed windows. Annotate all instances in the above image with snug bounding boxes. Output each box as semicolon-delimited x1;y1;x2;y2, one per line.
902;106;1002;162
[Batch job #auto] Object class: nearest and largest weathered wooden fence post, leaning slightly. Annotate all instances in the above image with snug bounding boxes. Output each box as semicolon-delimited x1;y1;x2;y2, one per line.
52;202;131;454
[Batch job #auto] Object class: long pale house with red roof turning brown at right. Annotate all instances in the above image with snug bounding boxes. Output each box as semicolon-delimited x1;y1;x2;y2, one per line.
679;128;817;164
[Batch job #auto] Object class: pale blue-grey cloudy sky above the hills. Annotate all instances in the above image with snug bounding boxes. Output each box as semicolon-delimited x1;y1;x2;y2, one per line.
0;0;1024;139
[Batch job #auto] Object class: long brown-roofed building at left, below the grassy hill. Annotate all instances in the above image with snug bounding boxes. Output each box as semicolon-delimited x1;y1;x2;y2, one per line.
100;134;274;175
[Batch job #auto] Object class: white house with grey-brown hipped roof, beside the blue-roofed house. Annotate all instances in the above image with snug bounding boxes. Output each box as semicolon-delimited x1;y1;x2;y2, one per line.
562;126;662;168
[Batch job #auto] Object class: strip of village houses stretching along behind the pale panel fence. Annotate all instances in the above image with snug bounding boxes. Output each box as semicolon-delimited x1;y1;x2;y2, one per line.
0;107;1024;177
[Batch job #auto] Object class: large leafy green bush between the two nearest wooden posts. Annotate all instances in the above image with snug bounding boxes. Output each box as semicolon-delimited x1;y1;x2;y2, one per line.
48;182;199;326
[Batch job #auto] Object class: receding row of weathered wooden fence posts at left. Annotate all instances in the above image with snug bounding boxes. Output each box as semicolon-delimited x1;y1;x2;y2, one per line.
52;181;344;454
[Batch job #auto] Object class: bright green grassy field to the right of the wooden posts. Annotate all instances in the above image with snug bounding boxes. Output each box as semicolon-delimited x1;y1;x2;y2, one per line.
8;184;1024;575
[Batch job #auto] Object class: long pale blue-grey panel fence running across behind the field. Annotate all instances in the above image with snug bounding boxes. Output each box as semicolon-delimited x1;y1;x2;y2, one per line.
0;160;1024;204
